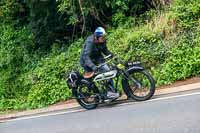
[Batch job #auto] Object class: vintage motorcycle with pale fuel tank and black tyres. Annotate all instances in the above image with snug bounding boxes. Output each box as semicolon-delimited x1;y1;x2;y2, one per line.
66;55;155;109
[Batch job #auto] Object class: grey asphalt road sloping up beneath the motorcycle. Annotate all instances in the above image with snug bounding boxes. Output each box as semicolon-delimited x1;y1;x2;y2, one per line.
0;91;200;133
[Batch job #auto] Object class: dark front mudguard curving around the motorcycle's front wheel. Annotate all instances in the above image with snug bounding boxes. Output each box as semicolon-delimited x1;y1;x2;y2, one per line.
122;66;144;97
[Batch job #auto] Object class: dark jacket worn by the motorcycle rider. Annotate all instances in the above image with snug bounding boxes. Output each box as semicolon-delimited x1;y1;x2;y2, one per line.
80;35;112;70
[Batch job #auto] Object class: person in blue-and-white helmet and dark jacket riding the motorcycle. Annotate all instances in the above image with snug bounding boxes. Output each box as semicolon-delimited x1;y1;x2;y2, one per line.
80;27;119;99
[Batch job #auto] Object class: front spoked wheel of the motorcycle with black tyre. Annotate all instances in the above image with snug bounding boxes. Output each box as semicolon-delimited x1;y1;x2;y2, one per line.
126;70;155;101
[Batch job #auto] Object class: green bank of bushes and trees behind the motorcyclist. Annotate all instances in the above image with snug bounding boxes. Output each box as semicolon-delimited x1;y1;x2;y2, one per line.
0;0;200;111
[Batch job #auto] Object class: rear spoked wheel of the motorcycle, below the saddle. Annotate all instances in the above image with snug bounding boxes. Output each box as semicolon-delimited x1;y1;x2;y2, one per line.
73;85;98;110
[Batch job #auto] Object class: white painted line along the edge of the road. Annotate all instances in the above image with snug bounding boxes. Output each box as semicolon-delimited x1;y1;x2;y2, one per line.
1;92;200;122
